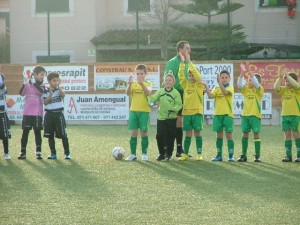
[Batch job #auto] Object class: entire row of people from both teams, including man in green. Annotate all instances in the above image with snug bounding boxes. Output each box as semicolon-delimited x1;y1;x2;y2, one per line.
0;41;300;162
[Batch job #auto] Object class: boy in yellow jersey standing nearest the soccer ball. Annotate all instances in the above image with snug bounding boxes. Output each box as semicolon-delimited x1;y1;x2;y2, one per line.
125;64;152;161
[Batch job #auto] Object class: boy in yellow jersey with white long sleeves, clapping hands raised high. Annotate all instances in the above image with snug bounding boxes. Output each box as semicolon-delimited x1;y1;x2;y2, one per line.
237;63;264;162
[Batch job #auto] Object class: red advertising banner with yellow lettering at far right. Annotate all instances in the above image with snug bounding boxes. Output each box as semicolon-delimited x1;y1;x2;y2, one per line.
246;62;300;90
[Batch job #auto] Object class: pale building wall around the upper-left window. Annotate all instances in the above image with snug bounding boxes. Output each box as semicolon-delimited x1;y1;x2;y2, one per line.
10;0;96;63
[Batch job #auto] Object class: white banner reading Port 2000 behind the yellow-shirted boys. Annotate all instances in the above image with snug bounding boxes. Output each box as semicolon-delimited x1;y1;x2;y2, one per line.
195;63;234;90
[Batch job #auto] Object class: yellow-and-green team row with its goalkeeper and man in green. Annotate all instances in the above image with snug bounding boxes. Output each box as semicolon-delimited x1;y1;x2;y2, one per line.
125;41;300;162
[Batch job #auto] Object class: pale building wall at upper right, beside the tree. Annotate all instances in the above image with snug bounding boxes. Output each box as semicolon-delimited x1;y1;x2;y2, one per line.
231;0;300;45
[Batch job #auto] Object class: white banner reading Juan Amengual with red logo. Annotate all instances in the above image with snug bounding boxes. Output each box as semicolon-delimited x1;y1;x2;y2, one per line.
64;94;129;120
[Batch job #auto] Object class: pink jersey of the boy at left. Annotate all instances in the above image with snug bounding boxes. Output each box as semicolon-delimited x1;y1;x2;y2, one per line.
20;83;44;116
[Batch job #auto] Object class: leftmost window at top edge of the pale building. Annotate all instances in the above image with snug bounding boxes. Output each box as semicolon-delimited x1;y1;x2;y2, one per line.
35;0;70;13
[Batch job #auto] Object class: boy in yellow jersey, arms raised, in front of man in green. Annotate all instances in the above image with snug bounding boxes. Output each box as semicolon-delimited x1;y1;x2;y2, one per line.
178;52;208;161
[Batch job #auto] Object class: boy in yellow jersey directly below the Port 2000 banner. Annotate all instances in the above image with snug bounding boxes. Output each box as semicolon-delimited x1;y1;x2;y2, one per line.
206;70;234;162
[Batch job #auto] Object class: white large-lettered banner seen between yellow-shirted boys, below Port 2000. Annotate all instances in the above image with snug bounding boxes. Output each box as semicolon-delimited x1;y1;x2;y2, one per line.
204;93;272;119
